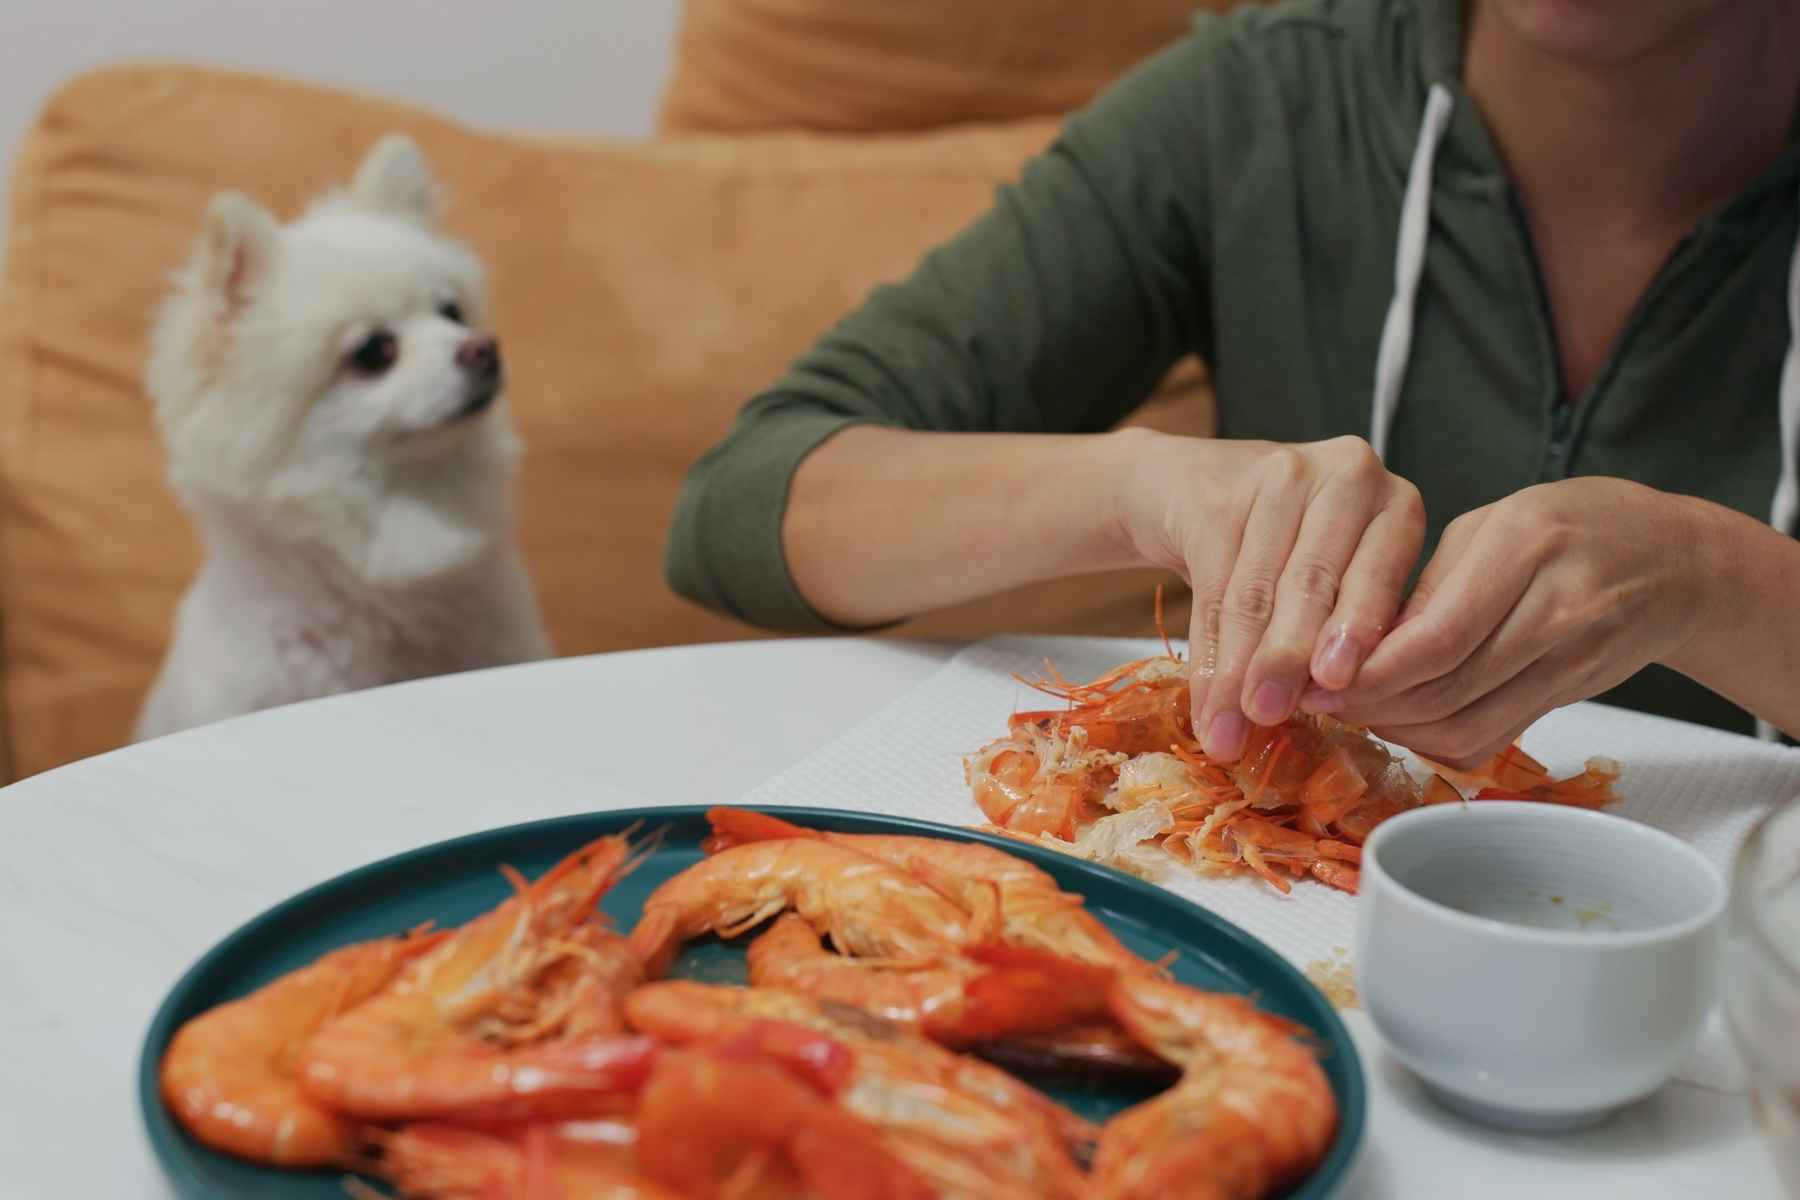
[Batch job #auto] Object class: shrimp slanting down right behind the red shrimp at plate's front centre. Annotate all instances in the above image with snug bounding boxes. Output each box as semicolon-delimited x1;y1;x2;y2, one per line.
625;982;1093;1200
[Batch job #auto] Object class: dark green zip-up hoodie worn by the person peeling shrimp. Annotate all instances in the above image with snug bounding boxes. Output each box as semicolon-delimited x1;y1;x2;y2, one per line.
666;0;1800;730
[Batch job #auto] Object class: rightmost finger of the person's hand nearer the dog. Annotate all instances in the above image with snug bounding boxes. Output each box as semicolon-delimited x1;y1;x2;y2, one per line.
1309;480;1426;691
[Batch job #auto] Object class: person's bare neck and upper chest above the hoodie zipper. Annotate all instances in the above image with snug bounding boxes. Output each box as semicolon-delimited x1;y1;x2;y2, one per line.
1463;0;1800;237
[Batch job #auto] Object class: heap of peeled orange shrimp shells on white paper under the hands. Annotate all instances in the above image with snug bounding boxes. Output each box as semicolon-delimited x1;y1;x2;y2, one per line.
963;618;1620;894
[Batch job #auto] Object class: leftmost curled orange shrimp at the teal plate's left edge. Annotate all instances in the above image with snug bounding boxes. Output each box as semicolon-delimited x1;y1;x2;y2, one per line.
160;932;443;1168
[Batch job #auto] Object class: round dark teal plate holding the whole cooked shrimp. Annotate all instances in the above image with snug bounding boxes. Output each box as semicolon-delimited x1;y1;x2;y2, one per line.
139;806;1368;1200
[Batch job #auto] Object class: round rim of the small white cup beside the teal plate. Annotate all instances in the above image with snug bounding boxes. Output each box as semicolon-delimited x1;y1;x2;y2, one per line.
1363;801;1732;952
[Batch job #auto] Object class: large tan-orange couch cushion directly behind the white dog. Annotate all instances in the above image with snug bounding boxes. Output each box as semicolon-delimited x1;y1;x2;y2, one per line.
0;67;1210;774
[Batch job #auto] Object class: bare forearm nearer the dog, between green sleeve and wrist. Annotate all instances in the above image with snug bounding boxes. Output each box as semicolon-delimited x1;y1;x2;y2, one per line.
781;425;1147;626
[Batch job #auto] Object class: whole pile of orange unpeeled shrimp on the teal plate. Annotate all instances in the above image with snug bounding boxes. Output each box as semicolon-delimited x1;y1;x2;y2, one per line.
160;810;1337;1200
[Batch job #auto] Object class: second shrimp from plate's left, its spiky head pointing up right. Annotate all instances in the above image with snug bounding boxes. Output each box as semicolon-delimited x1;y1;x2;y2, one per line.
299;837;655;1123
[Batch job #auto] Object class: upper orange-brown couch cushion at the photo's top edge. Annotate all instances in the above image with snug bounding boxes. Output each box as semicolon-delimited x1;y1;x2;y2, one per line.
661;0;1237;133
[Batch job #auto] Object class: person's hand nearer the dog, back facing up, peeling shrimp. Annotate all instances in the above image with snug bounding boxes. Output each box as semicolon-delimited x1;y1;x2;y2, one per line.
1120;430;1426;763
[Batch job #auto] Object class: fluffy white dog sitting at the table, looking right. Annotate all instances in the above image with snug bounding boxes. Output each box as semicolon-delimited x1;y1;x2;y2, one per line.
137;137;549;738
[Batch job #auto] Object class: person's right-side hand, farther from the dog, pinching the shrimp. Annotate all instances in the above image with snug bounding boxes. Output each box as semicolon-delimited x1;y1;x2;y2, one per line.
1301;477;1710;766
